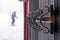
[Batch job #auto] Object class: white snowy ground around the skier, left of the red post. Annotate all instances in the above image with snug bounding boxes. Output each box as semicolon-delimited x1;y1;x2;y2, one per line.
0;0;24;40
